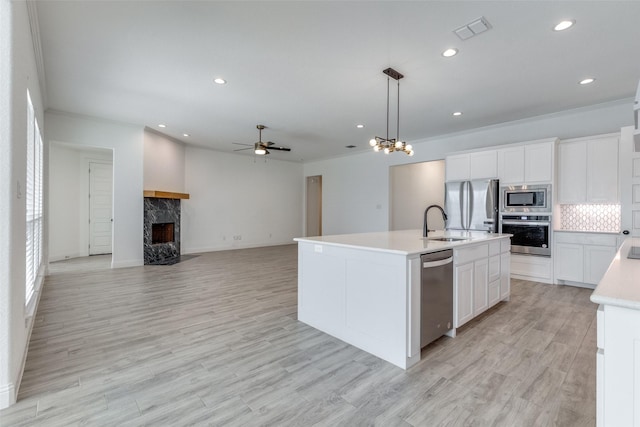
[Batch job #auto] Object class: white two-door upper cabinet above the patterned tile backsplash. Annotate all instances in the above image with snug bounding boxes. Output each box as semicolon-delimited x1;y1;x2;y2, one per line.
558;136;620;204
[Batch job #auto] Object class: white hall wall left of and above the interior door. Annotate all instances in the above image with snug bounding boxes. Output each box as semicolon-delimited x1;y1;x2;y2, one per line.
49;143;112;262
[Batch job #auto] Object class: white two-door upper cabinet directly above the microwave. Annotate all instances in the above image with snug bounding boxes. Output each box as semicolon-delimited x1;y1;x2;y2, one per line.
498;140;555;185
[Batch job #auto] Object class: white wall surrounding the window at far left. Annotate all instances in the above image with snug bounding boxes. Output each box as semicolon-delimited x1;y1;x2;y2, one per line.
0;0;48;409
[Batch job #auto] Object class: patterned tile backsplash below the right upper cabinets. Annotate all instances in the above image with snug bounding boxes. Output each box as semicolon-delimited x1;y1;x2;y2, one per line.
560;205;621;233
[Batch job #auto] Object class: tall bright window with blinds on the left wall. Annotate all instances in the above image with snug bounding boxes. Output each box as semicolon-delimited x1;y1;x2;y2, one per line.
25;91;43;304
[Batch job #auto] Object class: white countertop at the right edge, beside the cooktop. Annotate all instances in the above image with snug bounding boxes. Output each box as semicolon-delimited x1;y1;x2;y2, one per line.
591;237;640;310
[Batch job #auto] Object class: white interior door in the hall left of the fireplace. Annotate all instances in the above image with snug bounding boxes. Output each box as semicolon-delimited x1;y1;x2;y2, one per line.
89;162;113;255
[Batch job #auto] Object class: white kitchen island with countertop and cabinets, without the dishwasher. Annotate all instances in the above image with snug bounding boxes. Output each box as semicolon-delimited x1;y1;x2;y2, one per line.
294;230;510;369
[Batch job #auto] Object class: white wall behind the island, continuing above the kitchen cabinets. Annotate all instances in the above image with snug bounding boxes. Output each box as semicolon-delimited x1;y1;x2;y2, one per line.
304;100;633;235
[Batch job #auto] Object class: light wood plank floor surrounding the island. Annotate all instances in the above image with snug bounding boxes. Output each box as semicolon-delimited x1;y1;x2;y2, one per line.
0;245;596;426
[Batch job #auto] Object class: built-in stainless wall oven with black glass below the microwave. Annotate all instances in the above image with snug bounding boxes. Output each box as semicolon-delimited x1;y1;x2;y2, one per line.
500;216;551;257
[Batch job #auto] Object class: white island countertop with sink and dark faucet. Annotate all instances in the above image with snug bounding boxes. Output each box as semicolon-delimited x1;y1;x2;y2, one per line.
293;230;511;255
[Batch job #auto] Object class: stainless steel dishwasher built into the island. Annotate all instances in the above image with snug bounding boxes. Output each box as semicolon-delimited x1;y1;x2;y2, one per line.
420;249;453;348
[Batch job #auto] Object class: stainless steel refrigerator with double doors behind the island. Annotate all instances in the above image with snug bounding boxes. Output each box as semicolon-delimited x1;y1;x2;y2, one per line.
444;179;500;233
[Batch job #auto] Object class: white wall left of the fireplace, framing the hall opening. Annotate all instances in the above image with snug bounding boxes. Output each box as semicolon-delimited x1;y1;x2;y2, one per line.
45;111;144;268
